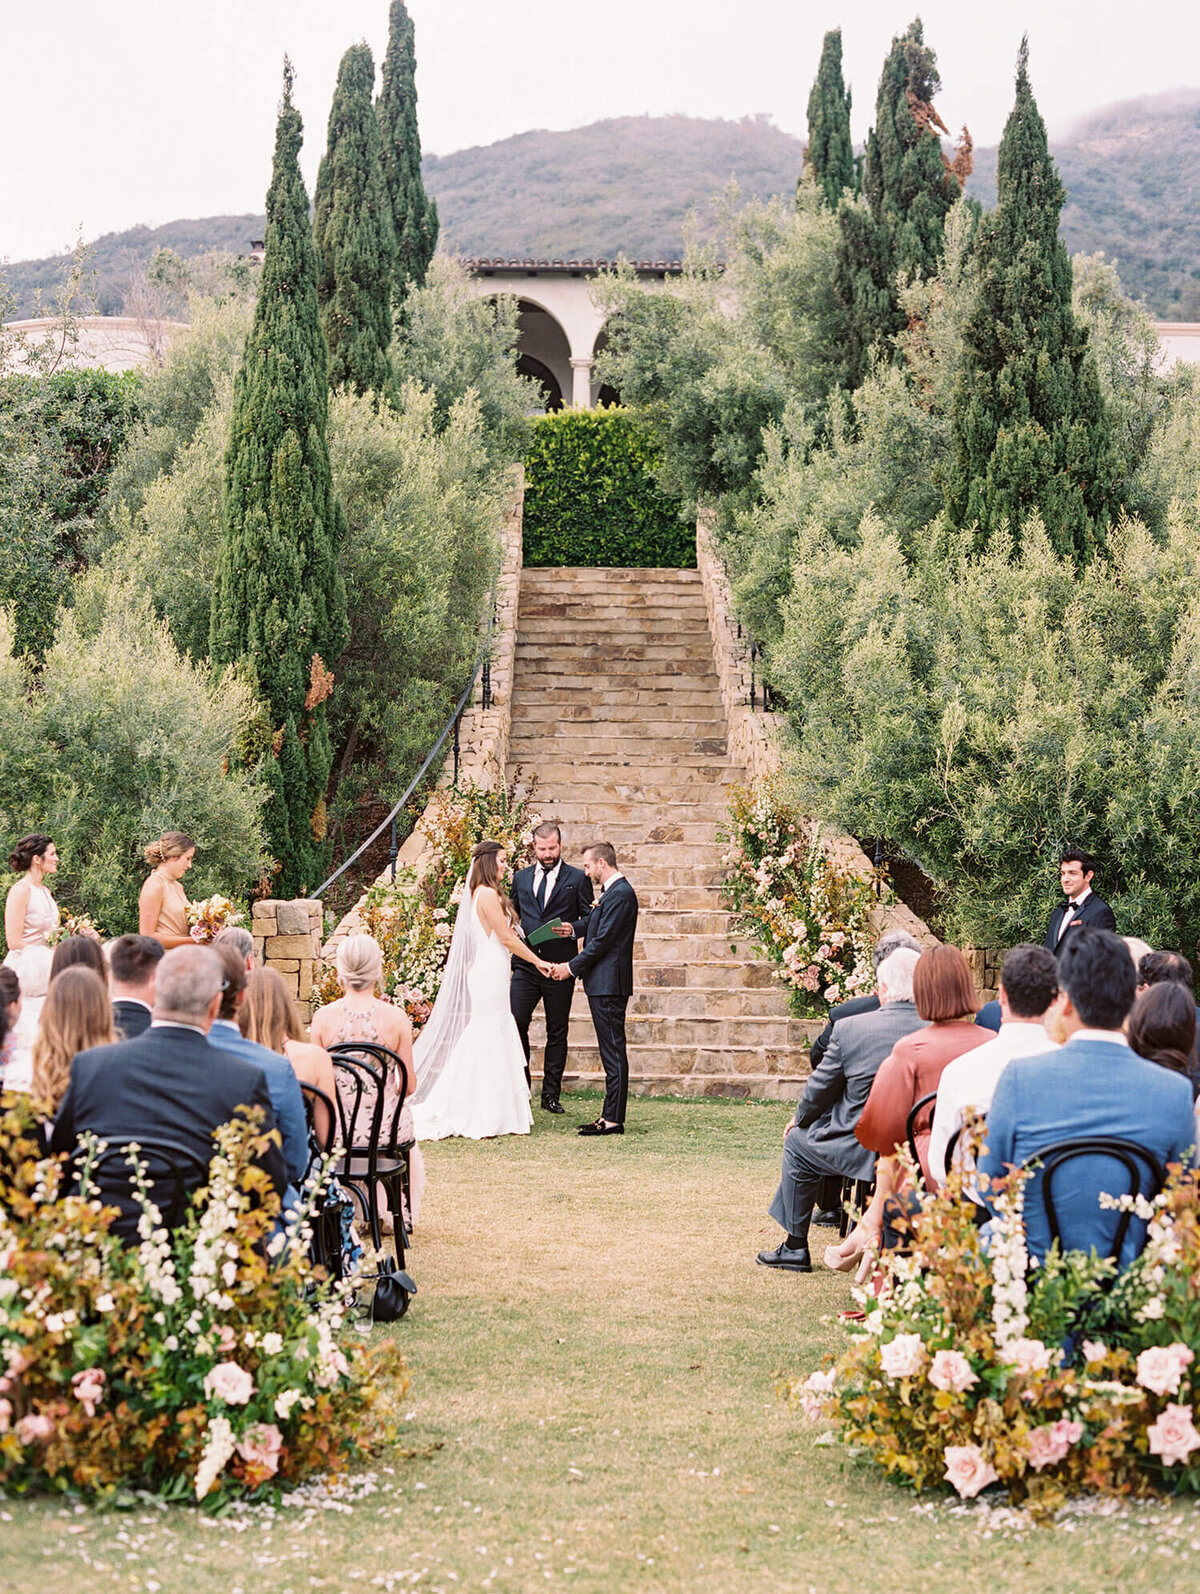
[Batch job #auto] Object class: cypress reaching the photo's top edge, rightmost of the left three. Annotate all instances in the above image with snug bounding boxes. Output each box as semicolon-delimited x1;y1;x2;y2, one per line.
378;0;438;304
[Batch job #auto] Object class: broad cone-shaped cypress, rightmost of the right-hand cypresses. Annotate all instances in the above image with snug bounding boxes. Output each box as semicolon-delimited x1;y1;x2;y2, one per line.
947;40;1120;558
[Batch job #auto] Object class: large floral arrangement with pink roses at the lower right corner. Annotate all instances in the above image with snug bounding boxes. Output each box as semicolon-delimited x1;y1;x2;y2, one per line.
786;1170;1200;1519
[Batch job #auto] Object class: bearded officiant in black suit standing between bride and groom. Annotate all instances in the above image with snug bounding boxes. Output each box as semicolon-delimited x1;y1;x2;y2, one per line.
508;821;594;1113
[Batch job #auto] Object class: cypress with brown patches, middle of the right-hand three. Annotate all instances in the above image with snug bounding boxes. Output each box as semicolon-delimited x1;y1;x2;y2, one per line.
833;18;959;387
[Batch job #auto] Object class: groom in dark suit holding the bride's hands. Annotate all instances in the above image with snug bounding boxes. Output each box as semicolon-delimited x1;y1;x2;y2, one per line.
553;842;637;1135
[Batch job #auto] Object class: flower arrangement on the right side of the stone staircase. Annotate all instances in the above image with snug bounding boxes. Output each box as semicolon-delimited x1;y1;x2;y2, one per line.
724;778;880;1015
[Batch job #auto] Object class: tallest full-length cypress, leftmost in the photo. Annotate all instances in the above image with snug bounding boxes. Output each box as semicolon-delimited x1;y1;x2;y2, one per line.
209;62;347;896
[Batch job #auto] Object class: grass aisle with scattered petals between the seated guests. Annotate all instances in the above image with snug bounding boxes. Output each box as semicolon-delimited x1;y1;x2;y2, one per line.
0;1097;1200;1594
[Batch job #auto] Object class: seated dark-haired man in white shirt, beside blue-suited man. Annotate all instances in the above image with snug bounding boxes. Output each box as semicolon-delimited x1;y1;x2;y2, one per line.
929;942;1058;1184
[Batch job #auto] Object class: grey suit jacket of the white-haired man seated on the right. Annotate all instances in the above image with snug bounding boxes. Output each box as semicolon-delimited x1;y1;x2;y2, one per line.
795;1001;924;1180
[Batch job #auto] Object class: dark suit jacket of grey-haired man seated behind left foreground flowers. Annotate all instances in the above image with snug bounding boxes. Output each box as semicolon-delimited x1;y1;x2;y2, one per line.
49;1025;287;1239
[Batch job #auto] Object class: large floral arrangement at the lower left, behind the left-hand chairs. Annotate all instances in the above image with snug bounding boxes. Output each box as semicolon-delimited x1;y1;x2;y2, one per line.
0;1095;408;1505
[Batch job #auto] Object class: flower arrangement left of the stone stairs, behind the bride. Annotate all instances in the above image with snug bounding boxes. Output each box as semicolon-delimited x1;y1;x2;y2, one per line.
312;783;542;1030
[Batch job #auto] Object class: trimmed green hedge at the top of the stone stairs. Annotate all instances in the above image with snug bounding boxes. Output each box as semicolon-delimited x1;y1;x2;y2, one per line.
524;408;696;569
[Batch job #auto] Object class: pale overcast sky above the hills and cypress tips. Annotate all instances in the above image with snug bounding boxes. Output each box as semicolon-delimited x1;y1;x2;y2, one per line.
0;0;1200;260
